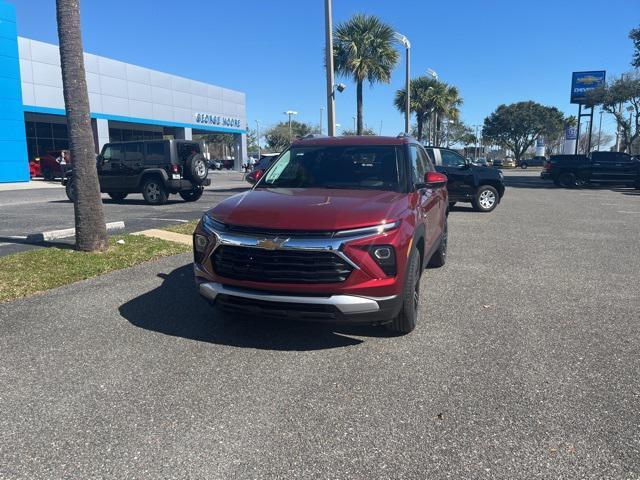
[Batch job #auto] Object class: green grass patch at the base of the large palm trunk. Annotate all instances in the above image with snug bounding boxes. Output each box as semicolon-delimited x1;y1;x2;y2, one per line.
0;235;191;303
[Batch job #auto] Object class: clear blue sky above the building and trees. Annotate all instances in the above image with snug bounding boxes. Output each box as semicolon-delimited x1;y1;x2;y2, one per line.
9;0;640;135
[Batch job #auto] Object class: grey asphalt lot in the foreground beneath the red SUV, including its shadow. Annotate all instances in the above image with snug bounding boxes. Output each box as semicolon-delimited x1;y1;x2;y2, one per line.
0;172;640;480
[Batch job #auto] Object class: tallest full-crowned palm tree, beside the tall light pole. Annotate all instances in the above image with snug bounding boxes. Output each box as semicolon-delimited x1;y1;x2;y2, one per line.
333;15;399;135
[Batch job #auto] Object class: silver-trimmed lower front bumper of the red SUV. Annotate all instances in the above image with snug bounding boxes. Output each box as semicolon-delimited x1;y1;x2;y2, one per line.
198;282;401;324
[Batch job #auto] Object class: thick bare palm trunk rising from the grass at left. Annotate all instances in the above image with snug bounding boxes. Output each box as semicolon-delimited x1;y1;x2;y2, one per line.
56;0;108;251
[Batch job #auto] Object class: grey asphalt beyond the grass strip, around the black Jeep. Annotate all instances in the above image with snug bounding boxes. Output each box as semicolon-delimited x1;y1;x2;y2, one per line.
0;171;250;256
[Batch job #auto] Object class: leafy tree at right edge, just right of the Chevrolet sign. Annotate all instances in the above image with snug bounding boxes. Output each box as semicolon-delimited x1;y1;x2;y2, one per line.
587;73;640;153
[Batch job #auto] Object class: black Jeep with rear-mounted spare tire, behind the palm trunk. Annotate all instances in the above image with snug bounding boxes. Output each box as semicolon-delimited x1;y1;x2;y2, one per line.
63;140;211;205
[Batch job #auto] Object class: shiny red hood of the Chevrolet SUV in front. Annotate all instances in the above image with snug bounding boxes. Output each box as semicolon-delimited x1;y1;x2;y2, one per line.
208;188;409;231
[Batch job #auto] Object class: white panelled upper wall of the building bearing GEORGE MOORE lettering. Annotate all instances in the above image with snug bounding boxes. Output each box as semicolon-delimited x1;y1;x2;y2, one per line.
18;37;247;133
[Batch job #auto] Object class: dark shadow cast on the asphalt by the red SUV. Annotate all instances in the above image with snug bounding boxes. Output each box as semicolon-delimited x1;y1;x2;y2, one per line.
119;265;390;351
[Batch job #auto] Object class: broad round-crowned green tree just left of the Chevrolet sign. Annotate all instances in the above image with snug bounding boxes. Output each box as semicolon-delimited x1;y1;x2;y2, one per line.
482;101;564;162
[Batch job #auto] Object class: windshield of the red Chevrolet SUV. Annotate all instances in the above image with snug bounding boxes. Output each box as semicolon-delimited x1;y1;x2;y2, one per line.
257;146;400;191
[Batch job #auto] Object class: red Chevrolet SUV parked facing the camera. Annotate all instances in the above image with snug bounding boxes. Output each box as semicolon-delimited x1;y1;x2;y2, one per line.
193;136;448;333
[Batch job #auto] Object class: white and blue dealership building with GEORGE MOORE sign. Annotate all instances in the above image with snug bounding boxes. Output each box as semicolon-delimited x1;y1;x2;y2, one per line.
0;0;247;182
